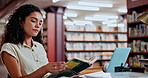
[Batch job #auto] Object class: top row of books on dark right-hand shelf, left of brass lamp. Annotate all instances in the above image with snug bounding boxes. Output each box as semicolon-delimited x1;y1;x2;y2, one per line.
127;11;142;23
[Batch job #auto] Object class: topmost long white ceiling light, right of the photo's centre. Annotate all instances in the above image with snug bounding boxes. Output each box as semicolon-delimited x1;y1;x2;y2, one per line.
78;2;113;7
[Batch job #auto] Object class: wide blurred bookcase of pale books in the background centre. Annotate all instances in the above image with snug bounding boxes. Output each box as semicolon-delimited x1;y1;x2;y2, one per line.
65;26;127;65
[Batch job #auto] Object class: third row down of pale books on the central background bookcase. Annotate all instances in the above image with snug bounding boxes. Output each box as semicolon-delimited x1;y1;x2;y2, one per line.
66;42;127;50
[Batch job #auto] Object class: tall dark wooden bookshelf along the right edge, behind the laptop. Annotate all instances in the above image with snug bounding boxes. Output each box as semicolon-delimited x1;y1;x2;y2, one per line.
127;0;148;72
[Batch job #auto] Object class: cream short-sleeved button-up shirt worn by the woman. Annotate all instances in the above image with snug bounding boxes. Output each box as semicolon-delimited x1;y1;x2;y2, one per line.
0;40;48;75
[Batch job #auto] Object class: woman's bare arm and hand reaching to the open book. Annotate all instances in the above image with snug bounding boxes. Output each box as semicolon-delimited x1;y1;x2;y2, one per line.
2;52;66;78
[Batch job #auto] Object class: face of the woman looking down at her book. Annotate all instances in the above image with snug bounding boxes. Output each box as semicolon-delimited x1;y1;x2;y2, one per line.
22;12;43;37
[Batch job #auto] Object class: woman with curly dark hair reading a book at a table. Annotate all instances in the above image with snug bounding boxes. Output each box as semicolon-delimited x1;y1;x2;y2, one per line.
0;4;66;78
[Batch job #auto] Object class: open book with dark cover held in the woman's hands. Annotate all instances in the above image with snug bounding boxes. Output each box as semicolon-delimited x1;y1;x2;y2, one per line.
48;57;98;78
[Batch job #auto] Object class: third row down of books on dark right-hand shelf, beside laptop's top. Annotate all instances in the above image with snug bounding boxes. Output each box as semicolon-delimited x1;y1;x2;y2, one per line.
128;40;148;52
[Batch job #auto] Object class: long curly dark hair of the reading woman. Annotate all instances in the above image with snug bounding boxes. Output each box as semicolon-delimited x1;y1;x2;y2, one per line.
2;4;42;44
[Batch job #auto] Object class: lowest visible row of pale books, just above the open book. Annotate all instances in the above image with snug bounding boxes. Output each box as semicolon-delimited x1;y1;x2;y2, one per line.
66;52;113;60
